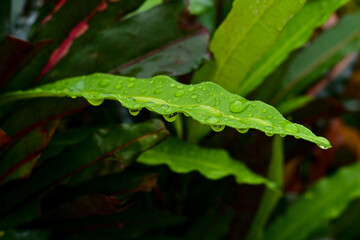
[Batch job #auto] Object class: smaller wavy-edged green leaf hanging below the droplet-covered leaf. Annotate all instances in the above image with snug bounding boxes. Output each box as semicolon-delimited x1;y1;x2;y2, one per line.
137;137;276;188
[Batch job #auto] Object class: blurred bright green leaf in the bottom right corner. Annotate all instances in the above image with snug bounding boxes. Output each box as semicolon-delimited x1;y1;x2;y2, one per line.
265;163;360;240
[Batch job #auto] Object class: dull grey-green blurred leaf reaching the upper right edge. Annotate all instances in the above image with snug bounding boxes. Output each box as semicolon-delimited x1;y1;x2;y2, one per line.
273;12;360;103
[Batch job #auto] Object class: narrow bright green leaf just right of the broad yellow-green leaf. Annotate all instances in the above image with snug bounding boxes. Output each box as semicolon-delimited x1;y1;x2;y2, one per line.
239;0;349;96
